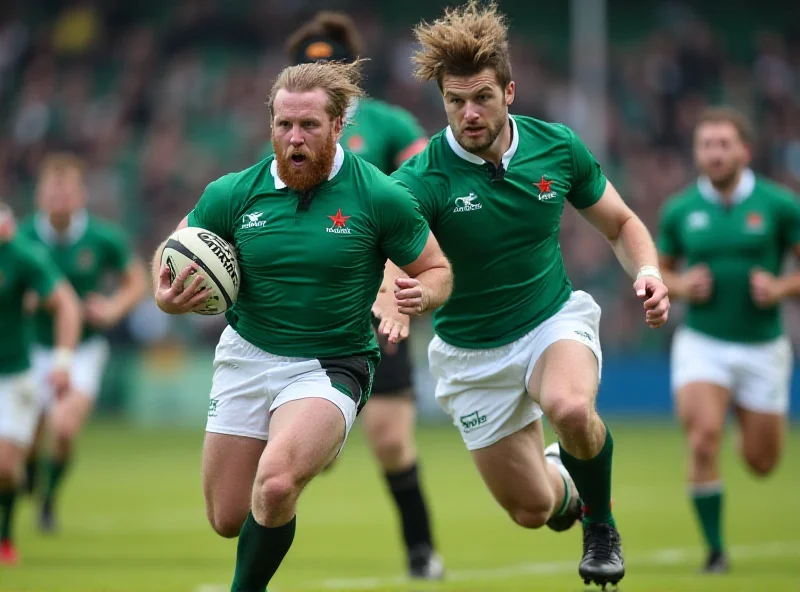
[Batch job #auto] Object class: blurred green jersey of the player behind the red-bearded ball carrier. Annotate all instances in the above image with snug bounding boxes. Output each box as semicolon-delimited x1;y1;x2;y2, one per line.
263;98;425;175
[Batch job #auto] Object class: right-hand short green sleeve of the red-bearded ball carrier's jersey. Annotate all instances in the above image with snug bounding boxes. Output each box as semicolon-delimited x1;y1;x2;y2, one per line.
373;178;430;267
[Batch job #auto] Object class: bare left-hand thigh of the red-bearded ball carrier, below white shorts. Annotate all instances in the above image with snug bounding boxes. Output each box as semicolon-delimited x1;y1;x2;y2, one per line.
203;432;267;538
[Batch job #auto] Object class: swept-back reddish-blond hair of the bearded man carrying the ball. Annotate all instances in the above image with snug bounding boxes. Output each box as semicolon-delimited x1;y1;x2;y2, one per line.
268;60;366;123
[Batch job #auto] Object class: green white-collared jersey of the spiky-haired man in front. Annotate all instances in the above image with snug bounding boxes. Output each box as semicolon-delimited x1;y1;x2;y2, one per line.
392;115;606;349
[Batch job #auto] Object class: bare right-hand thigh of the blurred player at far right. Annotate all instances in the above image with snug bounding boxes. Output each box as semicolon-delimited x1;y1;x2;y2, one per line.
735;406;788;477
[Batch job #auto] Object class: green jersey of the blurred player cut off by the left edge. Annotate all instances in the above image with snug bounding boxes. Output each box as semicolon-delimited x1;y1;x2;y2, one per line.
0;235;60;375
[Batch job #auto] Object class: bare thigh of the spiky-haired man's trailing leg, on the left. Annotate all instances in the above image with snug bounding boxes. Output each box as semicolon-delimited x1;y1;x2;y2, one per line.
471;420;563;528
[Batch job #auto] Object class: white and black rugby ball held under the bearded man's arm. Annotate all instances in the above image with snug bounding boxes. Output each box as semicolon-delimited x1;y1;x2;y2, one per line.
161;226;241;315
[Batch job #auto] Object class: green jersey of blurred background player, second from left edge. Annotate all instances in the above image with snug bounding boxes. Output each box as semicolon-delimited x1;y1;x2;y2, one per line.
19;211;131;347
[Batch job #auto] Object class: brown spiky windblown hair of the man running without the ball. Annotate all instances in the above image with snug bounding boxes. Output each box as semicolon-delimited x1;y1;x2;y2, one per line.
412;0;511;89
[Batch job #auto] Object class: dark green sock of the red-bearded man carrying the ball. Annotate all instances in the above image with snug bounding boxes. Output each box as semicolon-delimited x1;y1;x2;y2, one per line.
231;512;297;592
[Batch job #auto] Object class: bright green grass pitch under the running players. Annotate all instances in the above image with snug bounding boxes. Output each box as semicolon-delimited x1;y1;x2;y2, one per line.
0;421;800;592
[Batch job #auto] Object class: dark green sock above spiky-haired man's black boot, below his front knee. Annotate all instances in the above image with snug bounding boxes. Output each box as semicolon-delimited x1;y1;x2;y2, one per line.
559;426;616;527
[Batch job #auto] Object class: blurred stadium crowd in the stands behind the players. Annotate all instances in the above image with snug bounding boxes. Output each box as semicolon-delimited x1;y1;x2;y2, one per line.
0;0;800;351
